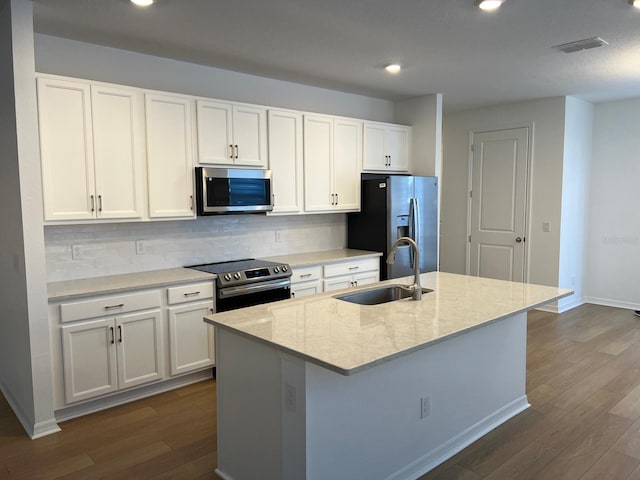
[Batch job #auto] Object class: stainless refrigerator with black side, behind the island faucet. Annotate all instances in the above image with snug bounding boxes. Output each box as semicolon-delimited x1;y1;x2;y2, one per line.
347;174;438;280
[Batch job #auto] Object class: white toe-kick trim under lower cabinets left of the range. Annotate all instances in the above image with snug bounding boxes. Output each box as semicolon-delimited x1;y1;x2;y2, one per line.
55;367;213;422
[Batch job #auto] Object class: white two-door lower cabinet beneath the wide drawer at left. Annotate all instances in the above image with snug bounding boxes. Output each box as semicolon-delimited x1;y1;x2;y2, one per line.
61;309;164;403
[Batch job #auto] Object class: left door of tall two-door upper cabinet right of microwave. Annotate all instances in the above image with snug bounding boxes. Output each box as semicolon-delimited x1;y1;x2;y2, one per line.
304;115;334;212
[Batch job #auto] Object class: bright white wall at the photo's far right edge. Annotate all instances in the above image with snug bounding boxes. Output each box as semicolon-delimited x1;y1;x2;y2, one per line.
585;98;640;309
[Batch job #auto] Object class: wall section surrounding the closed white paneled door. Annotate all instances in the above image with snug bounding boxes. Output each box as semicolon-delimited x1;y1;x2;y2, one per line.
440;97;565;285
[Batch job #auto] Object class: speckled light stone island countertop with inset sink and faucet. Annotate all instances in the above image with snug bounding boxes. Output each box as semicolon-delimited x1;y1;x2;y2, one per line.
205;272;573;375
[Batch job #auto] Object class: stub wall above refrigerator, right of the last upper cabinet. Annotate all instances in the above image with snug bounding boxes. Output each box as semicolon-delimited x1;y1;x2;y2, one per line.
395;93;442;177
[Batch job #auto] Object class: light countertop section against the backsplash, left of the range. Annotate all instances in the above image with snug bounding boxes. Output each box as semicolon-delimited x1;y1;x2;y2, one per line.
47;267;216;302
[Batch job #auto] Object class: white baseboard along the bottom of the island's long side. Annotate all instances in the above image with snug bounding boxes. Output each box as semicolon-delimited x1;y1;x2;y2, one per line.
388;395;531;480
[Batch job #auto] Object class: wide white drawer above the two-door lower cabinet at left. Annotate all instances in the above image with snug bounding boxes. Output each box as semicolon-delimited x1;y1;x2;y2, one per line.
60;290;160;323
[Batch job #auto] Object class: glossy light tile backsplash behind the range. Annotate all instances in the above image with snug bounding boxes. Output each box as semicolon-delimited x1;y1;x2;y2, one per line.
44;214;346;282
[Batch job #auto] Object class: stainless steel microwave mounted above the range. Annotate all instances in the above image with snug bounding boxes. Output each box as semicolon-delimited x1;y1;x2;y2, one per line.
196;167;273;215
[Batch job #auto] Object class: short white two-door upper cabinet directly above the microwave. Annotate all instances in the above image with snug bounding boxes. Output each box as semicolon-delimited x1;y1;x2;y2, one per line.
196;100;267;168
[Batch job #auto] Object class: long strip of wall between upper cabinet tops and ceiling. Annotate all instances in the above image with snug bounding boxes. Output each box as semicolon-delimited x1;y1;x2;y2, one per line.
35;34;394;122
